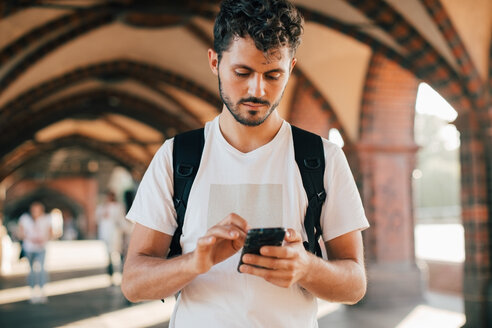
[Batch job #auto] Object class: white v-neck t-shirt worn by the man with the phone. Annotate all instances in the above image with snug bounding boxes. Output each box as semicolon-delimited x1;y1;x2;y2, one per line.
127;117;368;328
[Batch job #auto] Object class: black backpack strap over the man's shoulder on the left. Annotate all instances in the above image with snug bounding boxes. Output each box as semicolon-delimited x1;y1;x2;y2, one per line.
168;128;205;257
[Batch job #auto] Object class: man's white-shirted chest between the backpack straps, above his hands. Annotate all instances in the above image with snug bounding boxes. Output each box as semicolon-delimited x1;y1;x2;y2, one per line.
182;138;307;252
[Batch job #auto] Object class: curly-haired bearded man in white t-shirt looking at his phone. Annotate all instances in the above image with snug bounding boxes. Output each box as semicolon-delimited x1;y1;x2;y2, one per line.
122;0;368;327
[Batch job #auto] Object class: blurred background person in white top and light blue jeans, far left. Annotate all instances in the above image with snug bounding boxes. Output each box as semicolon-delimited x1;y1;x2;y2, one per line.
19;202;53;304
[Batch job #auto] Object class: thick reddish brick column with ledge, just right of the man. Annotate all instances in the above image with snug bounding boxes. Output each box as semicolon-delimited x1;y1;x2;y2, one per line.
355;54;423;306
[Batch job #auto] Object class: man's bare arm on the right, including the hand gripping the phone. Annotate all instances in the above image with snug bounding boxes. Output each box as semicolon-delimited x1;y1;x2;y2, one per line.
236;229;366;304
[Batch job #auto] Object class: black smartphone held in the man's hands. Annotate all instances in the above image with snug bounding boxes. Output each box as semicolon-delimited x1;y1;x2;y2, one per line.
237;227;286;272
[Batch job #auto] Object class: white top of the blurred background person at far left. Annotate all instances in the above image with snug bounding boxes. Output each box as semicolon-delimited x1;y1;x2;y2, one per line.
19;213;51;252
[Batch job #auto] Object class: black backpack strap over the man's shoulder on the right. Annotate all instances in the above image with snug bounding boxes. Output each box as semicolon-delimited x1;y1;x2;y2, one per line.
292;125;326;257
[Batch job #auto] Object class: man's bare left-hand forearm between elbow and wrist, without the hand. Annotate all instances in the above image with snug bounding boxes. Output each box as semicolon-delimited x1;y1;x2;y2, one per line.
121;253;198;302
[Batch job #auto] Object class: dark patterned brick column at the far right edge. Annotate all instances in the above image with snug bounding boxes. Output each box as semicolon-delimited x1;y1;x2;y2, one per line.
456;112;492;328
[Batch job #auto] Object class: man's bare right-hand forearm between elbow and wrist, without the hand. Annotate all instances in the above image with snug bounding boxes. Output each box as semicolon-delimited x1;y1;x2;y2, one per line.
299;254;366;304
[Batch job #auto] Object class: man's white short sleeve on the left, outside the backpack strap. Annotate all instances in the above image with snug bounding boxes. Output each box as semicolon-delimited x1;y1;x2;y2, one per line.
126;139;177;235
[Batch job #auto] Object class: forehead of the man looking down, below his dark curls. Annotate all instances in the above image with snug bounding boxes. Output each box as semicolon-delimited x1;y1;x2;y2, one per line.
222;37;291;67
